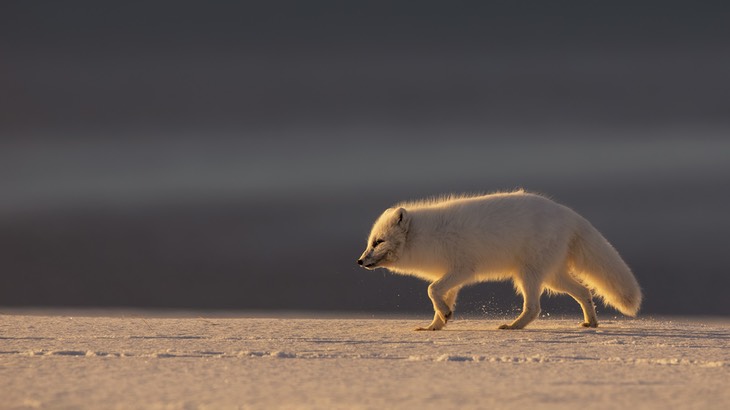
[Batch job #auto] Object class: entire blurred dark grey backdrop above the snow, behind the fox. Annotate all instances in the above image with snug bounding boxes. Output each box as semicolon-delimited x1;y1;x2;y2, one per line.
0;1;730;317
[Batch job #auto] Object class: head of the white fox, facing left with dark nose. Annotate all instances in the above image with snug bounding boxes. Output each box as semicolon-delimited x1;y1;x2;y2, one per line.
357;208;410;270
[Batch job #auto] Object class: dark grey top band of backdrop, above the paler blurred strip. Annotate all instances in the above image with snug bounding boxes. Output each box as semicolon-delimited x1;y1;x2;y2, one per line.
0;2;730;130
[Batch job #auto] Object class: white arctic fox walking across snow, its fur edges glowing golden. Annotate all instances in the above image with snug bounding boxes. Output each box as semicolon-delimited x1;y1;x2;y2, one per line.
357;190;642;330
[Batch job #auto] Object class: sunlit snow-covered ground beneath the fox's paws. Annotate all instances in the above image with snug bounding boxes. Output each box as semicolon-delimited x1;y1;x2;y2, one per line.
0;311;730;409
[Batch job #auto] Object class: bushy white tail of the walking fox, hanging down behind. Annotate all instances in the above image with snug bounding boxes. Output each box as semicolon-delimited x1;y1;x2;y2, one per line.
570;220;642;316
